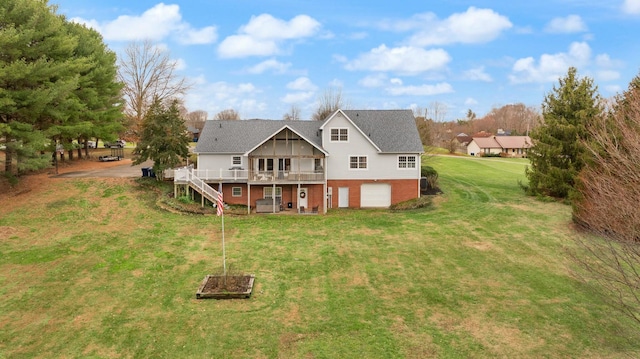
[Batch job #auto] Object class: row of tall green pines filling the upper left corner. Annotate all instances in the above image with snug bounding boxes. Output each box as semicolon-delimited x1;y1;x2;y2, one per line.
0;0;124;175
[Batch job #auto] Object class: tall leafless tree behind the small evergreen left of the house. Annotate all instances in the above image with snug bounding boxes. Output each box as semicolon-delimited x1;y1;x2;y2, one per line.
118;40;191;139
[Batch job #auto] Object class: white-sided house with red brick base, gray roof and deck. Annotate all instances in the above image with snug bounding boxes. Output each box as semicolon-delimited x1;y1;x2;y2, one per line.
184;110;423;213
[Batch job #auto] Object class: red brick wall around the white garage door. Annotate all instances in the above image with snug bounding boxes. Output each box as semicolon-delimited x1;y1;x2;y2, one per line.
327;179;420;208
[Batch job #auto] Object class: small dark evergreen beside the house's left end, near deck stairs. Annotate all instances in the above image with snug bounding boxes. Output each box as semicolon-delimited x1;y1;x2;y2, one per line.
133;97;190;180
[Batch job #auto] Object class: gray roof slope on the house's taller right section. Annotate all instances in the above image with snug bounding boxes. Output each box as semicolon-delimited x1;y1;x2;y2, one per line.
342;110;423;153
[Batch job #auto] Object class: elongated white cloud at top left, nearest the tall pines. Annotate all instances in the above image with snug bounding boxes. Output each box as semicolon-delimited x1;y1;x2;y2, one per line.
71;3;218;44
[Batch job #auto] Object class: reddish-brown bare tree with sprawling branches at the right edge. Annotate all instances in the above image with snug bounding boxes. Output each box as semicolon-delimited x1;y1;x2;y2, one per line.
573;77;640;322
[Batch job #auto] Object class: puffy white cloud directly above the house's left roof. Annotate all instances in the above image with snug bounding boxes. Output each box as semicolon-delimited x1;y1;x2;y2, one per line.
218;14;321;58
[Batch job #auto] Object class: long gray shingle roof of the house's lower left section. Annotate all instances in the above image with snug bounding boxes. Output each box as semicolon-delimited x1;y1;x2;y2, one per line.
195;120;322;153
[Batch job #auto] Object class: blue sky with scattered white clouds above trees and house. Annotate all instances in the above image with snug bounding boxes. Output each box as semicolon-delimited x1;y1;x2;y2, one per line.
50;0;640;120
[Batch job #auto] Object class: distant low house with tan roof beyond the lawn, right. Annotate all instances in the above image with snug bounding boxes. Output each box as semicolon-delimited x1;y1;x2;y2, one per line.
467;136;532;157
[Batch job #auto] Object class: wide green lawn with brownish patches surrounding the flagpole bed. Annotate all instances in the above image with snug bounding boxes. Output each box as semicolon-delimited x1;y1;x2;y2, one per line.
0;157;640;358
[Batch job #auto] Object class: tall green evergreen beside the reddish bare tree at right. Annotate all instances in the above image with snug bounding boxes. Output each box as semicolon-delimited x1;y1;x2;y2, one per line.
526;67;601;198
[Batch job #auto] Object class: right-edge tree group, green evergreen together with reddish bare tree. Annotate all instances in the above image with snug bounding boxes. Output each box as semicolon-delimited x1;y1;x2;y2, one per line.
522;67;640;322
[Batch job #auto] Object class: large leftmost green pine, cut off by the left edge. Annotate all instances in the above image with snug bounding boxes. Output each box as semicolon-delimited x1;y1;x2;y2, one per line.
0;0;82;174
